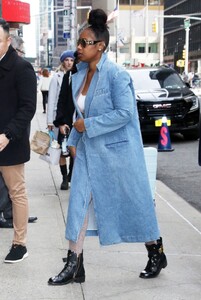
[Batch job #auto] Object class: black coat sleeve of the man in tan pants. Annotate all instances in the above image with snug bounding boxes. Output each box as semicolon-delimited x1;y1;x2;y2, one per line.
4;60;37;139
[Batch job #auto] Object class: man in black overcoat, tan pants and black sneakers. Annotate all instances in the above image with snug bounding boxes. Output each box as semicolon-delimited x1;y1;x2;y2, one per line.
0;18;37;263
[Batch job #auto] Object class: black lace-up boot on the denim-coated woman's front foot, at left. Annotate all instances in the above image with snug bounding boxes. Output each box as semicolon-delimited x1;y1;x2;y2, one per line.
48;250;85;285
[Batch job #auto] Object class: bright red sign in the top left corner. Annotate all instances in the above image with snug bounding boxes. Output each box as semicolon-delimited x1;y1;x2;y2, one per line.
2;0;30;24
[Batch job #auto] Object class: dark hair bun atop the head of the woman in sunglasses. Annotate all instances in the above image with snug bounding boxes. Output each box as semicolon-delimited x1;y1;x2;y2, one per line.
88;9;107;30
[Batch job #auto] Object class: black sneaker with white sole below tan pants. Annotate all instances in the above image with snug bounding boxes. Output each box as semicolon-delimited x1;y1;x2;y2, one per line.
4;245;28;264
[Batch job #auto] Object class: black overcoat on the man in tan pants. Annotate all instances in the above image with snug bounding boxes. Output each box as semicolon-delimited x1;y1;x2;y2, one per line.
0;46;37;166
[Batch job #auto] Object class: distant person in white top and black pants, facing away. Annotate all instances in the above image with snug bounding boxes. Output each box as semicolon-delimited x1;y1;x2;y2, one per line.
38;68;51;114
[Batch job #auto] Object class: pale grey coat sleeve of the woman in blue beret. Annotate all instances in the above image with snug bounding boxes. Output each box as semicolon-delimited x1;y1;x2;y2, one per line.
47;74;56;125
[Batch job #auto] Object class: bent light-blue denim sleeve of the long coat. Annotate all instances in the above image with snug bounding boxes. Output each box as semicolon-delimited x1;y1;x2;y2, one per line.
84;70;135;138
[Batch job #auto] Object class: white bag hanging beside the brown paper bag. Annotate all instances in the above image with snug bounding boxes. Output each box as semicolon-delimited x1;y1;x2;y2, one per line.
39;131;61;165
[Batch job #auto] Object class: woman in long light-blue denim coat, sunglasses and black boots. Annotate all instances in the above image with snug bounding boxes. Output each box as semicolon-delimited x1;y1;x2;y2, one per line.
48;9;167;285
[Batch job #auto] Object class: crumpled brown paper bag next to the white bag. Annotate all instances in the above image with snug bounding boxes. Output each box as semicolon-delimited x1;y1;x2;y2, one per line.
30;130;51;154
